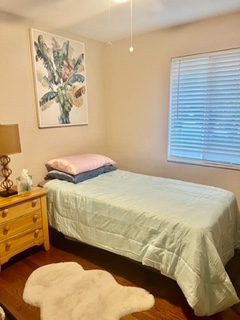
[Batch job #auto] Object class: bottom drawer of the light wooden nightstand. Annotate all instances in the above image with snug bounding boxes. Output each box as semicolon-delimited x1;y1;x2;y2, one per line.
0;228;43;262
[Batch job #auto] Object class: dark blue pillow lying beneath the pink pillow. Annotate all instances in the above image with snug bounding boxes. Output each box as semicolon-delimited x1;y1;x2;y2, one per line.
45;165;117;183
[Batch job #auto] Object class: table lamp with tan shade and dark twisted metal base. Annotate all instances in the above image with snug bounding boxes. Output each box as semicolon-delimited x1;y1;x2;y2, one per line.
0;124;21;197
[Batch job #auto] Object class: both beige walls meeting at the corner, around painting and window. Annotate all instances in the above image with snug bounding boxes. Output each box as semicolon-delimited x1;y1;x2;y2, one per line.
0;9;240;198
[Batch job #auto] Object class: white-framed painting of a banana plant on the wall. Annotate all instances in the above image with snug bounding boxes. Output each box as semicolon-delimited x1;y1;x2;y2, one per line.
31;29;88;128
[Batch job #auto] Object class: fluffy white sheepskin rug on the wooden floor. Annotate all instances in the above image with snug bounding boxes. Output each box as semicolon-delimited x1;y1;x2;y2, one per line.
23;262;154;320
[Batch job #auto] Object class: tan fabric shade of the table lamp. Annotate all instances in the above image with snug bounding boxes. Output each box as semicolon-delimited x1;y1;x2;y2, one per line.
0;124;21;156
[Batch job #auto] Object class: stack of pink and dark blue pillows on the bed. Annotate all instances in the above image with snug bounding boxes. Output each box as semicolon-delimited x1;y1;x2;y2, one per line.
45;153;116;183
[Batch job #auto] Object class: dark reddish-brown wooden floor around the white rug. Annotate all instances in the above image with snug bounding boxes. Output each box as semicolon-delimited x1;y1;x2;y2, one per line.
0;231;240;320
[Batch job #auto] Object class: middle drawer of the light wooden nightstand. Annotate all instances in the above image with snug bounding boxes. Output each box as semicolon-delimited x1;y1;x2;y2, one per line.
0;211;42;241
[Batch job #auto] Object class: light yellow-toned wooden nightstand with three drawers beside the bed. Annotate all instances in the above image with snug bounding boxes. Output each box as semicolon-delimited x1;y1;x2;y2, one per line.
0;187;49;271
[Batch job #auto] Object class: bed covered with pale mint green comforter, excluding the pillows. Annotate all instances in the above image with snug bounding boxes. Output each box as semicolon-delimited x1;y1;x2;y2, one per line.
44;169;240;316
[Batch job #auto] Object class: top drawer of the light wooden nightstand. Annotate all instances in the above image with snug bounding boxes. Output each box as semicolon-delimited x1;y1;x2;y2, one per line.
0;198;41;223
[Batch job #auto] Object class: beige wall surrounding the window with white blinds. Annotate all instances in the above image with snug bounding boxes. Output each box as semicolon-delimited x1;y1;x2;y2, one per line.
106;14;240;198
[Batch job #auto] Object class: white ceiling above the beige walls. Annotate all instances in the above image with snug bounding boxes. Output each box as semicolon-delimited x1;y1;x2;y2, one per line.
0;0;240;42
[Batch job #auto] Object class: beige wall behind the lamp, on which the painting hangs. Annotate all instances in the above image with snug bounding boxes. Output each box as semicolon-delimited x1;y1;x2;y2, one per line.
0;13;106;184
